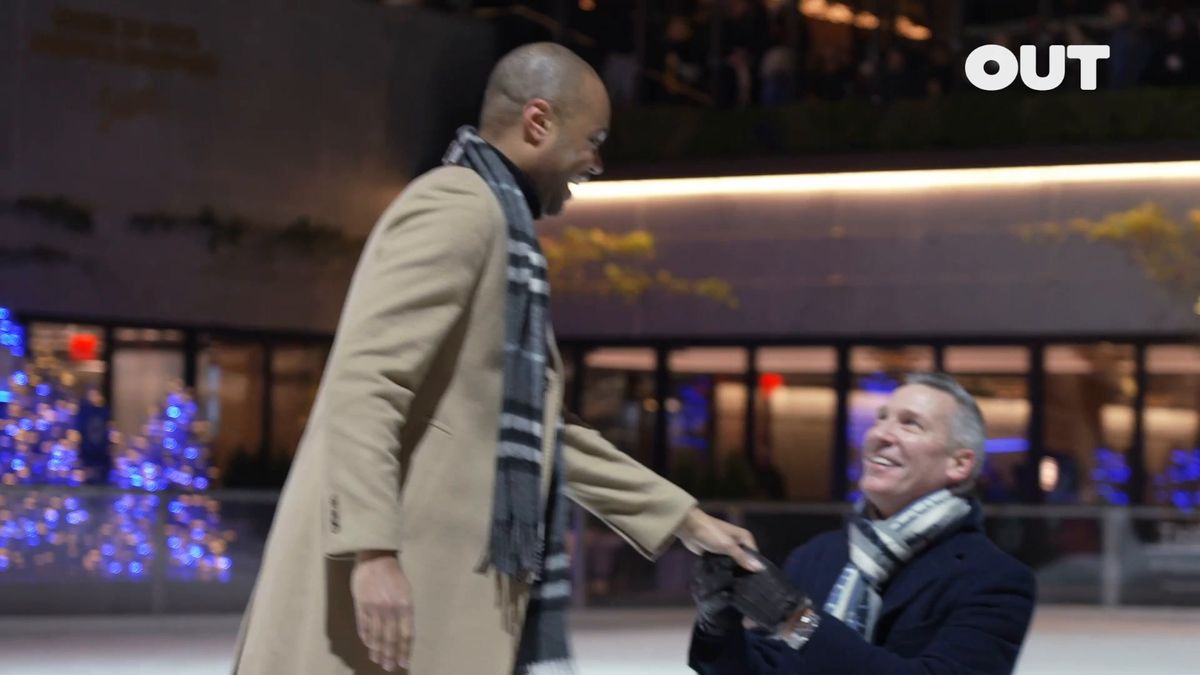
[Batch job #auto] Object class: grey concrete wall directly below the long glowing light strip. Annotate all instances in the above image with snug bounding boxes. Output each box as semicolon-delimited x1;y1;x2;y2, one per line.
547;174;1200;338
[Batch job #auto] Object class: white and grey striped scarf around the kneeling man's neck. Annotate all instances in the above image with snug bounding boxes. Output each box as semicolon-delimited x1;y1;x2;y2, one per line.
824;490;971;643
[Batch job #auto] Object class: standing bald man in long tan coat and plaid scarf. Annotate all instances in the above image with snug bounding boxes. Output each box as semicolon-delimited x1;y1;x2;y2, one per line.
234;43;758;675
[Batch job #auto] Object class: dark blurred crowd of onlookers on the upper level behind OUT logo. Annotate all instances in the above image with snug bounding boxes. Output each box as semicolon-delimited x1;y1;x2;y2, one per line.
633;0;1200;108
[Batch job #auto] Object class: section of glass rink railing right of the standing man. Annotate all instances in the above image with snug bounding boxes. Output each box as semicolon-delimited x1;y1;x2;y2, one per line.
575;502;1200;607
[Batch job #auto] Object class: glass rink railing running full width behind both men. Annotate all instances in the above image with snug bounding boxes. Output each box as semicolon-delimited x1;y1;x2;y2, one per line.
0;486;1200;615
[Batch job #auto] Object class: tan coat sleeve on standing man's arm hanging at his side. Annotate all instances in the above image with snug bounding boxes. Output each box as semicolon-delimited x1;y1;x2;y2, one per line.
320;175;497;556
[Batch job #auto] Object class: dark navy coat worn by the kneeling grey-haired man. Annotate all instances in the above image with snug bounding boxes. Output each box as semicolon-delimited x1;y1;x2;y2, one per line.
689;506;1036;675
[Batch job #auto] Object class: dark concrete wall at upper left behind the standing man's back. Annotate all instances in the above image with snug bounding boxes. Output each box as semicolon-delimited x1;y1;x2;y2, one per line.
0;0;493;330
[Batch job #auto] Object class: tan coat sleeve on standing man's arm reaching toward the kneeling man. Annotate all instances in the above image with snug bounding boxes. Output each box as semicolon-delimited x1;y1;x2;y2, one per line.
563;424;696;558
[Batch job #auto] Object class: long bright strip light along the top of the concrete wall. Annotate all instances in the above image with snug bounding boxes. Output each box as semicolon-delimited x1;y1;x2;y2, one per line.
572;161;1200;202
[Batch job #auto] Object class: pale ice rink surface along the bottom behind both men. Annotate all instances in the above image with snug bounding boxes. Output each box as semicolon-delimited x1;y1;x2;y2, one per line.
0;607;1200;675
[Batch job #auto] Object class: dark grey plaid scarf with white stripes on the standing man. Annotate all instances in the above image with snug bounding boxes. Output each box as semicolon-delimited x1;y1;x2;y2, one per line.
443;126;574;675
